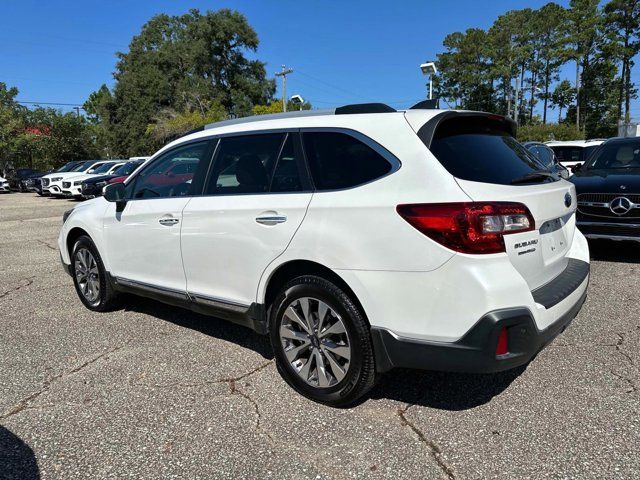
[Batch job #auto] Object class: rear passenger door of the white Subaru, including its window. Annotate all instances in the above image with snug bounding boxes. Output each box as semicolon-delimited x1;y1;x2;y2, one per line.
182;131;312;306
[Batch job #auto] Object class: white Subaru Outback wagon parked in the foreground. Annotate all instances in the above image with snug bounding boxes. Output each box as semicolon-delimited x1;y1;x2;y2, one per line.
58;104;589;406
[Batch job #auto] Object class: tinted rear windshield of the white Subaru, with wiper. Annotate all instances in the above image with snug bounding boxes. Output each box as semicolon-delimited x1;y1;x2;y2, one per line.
430;117;554;185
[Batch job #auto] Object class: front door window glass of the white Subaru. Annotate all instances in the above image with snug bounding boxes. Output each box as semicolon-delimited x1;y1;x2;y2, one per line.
131;142;209;199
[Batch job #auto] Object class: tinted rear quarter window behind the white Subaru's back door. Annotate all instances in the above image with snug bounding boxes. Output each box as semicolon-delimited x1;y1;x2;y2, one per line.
303;132;392;190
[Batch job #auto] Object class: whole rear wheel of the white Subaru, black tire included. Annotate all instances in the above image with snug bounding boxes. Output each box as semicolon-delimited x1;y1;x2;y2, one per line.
269;275;376;407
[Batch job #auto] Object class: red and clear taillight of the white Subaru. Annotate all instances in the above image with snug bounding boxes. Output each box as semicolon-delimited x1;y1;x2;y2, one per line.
396;202;535;253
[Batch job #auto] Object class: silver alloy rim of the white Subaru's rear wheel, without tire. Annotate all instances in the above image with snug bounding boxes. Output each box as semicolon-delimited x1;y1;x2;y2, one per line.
279;297;351;388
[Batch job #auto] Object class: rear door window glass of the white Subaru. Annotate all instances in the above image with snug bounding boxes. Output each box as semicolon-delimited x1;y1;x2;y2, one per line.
205;133;285;195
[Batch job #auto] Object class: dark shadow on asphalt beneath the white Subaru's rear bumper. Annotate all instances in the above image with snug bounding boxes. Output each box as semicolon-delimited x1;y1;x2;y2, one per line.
369;365;527;411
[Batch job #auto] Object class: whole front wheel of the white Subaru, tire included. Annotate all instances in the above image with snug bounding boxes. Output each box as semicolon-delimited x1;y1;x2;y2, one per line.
71;235;118;312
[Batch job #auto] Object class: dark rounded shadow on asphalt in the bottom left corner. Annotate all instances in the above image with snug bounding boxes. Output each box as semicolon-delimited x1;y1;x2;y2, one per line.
0;426;40;480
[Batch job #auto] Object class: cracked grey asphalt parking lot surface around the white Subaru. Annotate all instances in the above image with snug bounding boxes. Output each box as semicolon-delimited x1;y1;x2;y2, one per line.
0;194;640;479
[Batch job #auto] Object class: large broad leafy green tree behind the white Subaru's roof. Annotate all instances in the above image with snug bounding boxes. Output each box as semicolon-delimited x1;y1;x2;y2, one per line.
102;9;275;155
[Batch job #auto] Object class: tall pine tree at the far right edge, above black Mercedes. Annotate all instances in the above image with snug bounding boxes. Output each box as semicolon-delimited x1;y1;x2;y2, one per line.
604;0;640;122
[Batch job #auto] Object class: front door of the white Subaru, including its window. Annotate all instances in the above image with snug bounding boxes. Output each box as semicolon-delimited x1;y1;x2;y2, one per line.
104;140;213;295
